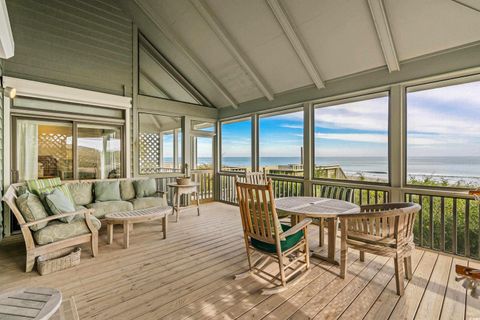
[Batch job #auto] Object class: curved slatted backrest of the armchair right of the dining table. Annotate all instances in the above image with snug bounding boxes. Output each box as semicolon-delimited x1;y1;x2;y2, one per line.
347;203;420;242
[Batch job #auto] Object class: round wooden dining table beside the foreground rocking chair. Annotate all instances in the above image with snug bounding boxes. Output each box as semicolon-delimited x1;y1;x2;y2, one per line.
275;197;360;264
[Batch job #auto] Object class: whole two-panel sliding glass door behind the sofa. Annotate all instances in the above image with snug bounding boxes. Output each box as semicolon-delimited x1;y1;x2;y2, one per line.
12;117;123;182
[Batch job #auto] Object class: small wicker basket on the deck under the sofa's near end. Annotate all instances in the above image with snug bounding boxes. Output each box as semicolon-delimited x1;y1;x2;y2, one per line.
37;247;82;276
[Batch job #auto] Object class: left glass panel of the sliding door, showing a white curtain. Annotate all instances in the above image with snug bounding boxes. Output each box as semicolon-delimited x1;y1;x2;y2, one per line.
13;119;73;181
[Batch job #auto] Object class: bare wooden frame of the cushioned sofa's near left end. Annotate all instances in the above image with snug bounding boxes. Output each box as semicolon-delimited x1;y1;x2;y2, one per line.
3;183;98;272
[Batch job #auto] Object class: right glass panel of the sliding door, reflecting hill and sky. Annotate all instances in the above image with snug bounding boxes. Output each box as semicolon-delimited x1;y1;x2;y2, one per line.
77;124;122;179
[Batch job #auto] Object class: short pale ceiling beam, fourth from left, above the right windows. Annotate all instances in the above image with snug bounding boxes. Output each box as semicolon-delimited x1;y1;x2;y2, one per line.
368;0;400;72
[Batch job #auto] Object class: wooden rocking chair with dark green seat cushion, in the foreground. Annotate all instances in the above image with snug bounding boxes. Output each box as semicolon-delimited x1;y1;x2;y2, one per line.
235;180;312;294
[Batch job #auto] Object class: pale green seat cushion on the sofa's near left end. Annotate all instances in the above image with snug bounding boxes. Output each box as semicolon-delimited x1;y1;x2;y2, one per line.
33;216;101;245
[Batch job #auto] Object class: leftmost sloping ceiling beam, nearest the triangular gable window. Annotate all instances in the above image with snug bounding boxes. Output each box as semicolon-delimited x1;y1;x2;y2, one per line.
135;0;238;109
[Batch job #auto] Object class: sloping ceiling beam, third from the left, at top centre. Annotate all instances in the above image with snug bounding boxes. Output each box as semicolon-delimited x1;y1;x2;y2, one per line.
267;0;325;89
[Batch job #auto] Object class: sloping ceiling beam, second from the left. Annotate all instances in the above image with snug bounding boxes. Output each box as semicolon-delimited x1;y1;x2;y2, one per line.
190;0;273;101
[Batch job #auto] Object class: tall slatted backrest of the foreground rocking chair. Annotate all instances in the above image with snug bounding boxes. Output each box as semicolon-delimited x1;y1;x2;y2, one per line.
236;180;281;244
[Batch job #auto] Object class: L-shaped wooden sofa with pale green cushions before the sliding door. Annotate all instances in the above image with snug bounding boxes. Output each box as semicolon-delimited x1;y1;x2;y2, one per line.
3;179;168;272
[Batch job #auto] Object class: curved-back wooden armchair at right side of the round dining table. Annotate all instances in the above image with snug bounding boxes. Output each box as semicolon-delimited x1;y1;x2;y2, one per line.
340;203;420;296
